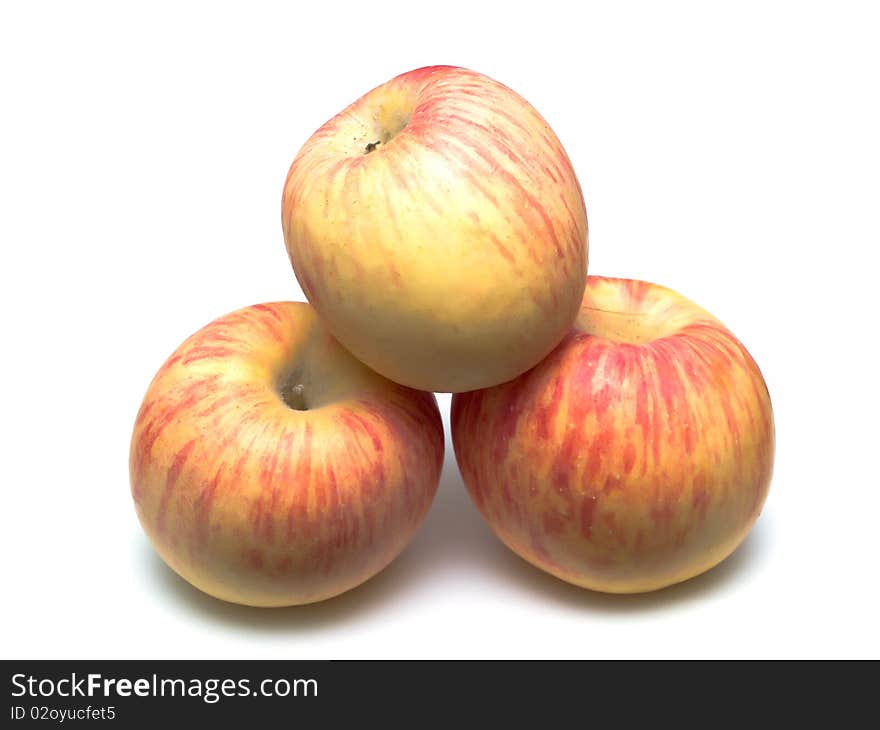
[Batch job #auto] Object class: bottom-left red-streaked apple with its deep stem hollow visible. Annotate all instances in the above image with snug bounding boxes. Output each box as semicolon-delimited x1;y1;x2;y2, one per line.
130;302;444;606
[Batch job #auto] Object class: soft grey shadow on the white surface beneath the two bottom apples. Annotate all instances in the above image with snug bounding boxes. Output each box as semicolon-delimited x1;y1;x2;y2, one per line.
138;444;771;632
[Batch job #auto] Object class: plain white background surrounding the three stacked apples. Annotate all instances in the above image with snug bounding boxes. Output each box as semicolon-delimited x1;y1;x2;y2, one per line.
0;0;880;658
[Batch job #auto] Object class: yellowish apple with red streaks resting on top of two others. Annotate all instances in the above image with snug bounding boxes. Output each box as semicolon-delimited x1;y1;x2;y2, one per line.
282;66;587;392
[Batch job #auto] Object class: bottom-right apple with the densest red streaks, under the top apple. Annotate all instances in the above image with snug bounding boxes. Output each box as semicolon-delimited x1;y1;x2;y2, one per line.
452;276;775;593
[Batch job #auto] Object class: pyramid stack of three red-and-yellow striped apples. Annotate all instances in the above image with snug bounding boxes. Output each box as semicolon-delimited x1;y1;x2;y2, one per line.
131;66;774;606
